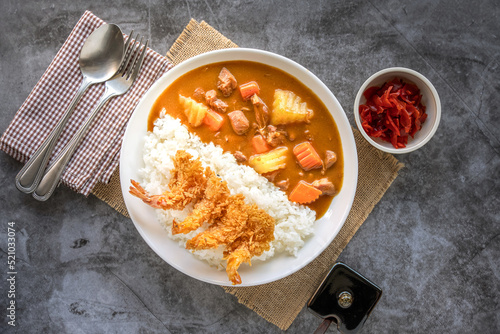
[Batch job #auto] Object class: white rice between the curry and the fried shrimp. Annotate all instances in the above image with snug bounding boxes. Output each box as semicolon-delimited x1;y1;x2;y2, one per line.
140;115;316;268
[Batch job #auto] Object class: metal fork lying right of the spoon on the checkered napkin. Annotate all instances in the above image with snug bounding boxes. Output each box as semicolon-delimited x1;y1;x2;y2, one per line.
33;31;149;201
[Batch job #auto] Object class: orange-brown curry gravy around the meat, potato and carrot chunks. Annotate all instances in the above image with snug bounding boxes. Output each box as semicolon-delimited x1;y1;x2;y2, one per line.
148;61;344;219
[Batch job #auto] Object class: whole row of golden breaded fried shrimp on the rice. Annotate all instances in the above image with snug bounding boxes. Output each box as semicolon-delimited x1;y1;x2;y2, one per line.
130;150;275;284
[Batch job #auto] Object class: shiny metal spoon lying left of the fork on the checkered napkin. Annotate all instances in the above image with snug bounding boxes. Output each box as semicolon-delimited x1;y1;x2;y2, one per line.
16;24;124;194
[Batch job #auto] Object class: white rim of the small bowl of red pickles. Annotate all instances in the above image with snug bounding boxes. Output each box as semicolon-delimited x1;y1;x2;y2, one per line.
353;67;441;154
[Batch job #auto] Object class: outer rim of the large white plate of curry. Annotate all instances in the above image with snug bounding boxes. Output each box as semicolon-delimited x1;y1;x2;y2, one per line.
120;48;358;287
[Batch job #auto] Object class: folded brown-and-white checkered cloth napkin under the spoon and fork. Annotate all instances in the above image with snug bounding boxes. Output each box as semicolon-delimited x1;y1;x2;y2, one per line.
0;11;173;196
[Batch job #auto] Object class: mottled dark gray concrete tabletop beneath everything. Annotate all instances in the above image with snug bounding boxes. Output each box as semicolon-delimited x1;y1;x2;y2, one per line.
0;0;500;333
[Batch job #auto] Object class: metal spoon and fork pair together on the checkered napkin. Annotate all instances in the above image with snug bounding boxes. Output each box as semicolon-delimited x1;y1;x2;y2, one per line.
16;24;149;201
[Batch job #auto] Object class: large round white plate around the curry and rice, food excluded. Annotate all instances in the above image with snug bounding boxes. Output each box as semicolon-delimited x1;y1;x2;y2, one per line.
120;48;358;286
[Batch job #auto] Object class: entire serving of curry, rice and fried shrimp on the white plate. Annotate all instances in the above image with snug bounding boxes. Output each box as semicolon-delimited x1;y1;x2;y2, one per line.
130;61;344;284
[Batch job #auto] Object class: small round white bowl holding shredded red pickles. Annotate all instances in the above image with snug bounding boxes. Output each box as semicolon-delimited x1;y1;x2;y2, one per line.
354;67;441;154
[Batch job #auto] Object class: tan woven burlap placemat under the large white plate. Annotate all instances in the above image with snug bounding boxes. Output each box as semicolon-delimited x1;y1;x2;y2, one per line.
93;19;403;330
